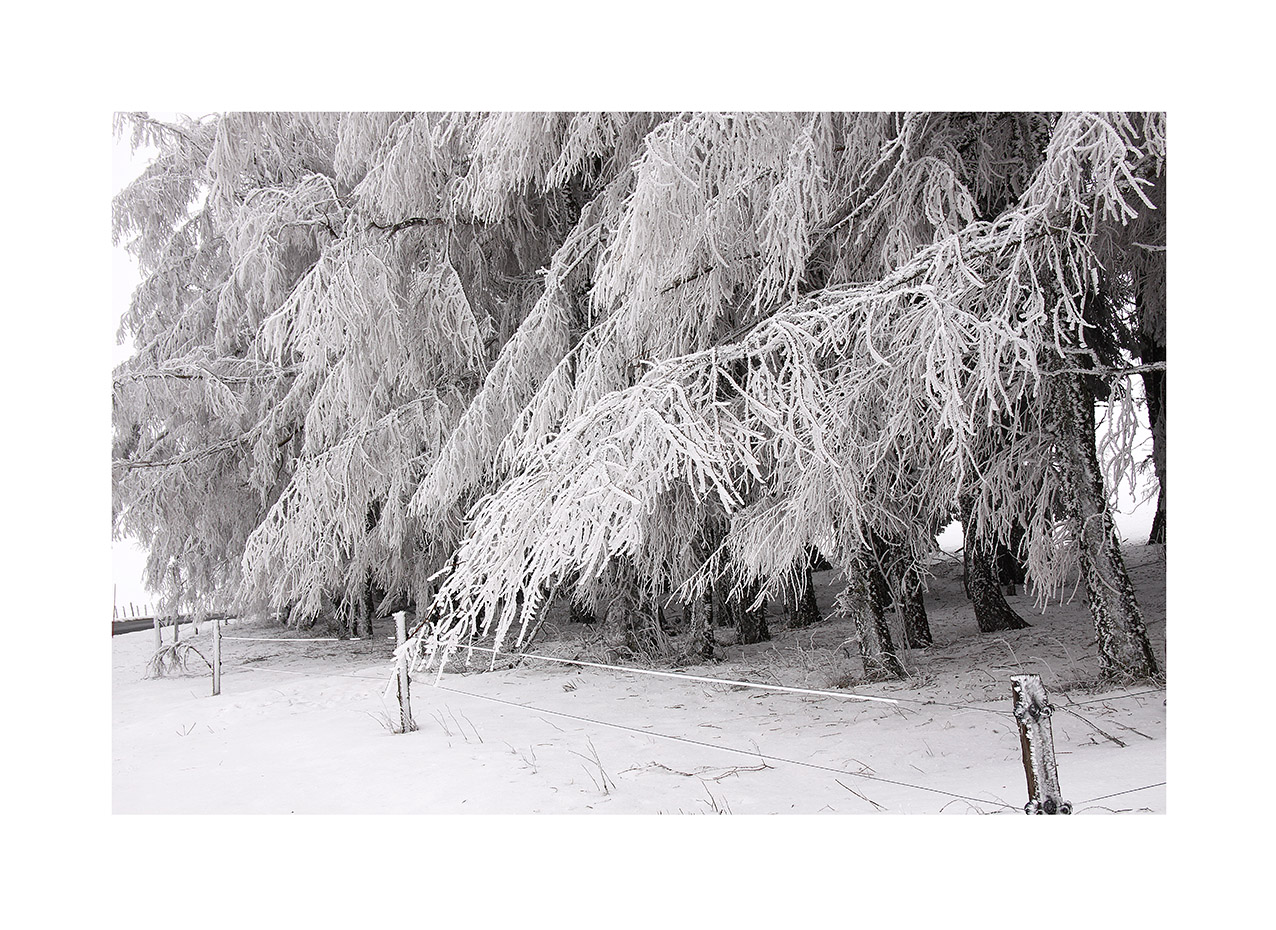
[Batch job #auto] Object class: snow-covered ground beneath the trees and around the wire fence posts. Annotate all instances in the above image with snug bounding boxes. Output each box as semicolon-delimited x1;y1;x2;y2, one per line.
112;546;1166;814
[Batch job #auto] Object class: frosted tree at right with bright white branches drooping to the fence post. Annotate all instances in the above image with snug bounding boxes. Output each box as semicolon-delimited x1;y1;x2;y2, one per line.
405;114;1165;676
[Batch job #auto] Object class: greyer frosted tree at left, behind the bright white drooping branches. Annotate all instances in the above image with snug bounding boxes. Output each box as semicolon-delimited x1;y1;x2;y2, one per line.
115;114;653;621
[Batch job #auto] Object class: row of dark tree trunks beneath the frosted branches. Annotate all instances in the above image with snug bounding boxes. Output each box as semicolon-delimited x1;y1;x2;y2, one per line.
332;359;1165;680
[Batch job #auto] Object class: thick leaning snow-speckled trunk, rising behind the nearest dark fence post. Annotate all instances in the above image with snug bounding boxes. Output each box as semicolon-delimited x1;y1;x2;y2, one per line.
1057;375;1157;680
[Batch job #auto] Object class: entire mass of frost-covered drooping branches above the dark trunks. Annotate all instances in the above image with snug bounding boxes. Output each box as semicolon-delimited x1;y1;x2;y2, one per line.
114;112;1166;675
